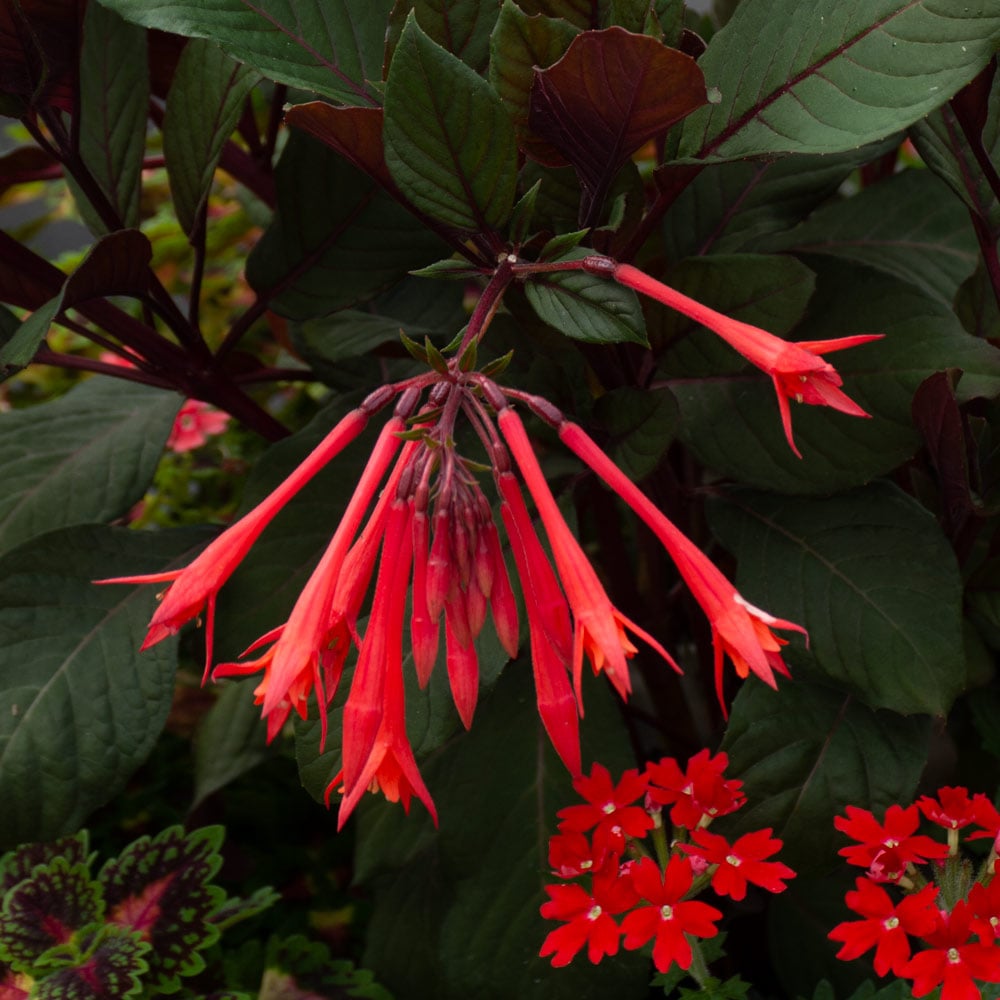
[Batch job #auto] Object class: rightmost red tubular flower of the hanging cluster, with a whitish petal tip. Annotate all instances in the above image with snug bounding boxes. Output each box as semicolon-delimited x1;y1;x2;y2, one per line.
559;420;808;714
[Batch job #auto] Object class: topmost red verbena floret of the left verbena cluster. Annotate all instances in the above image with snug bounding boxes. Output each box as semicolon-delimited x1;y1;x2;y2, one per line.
646;749;746;830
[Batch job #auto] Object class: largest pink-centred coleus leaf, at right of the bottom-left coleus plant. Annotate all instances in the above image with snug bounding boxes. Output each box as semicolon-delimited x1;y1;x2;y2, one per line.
98;826;225;993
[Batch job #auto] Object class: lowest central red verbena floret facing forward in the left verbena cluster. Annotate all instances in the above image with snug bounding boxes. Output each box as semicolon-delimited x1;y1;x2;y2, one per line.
622;854;722;972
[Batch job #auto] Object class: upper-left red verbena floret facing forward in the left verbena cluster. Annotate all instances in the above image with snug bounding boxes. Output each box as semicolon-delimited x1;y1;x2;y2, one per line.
558;763;653;854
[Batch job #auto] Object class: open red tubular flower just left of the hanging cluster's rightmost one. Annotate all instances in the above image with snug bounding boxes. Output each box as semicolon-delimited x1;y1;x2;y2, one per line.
497;407;681;700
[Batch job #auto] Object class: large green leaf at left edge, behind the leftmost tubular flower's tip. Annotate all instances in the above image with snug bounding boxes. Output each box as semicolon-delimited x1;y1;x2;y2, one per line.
0;526;203;846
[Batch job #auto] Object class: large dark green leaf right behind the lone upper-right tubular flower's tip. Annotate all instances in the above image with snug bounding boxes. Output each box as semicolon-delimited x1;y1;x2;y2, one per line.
666;258;1000;493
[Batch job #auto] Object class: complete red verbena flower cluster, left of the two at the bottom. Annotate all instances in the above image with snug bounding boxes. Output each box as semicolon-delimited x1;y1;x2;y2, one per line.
541;750;795;972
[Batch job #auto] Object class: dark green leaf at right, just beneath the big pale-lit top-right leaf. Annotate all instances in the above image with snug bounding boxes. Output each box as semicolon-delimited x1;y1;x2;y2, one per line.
764;170;979;306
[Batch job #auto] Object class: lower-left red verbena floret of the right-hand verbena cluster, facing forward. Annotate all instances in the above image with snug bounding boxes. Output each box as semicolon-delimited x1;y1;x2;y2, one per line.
827;878;940;976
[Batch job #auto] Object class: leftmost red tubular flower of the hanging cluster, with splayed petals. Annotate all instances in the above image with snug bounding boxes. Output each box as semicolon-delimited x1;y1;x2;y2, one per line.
96;407;386;679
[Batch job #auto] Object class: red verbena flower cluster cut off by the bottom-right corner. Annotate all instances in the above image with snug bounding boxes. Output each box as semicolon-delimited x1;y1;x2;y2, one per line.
829;787;1000;1000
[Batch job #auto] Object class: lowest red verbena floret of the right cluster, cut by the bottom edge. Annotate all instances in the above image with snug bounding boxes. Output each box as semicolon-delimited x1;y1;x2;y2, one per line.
899;900;1000;1000
